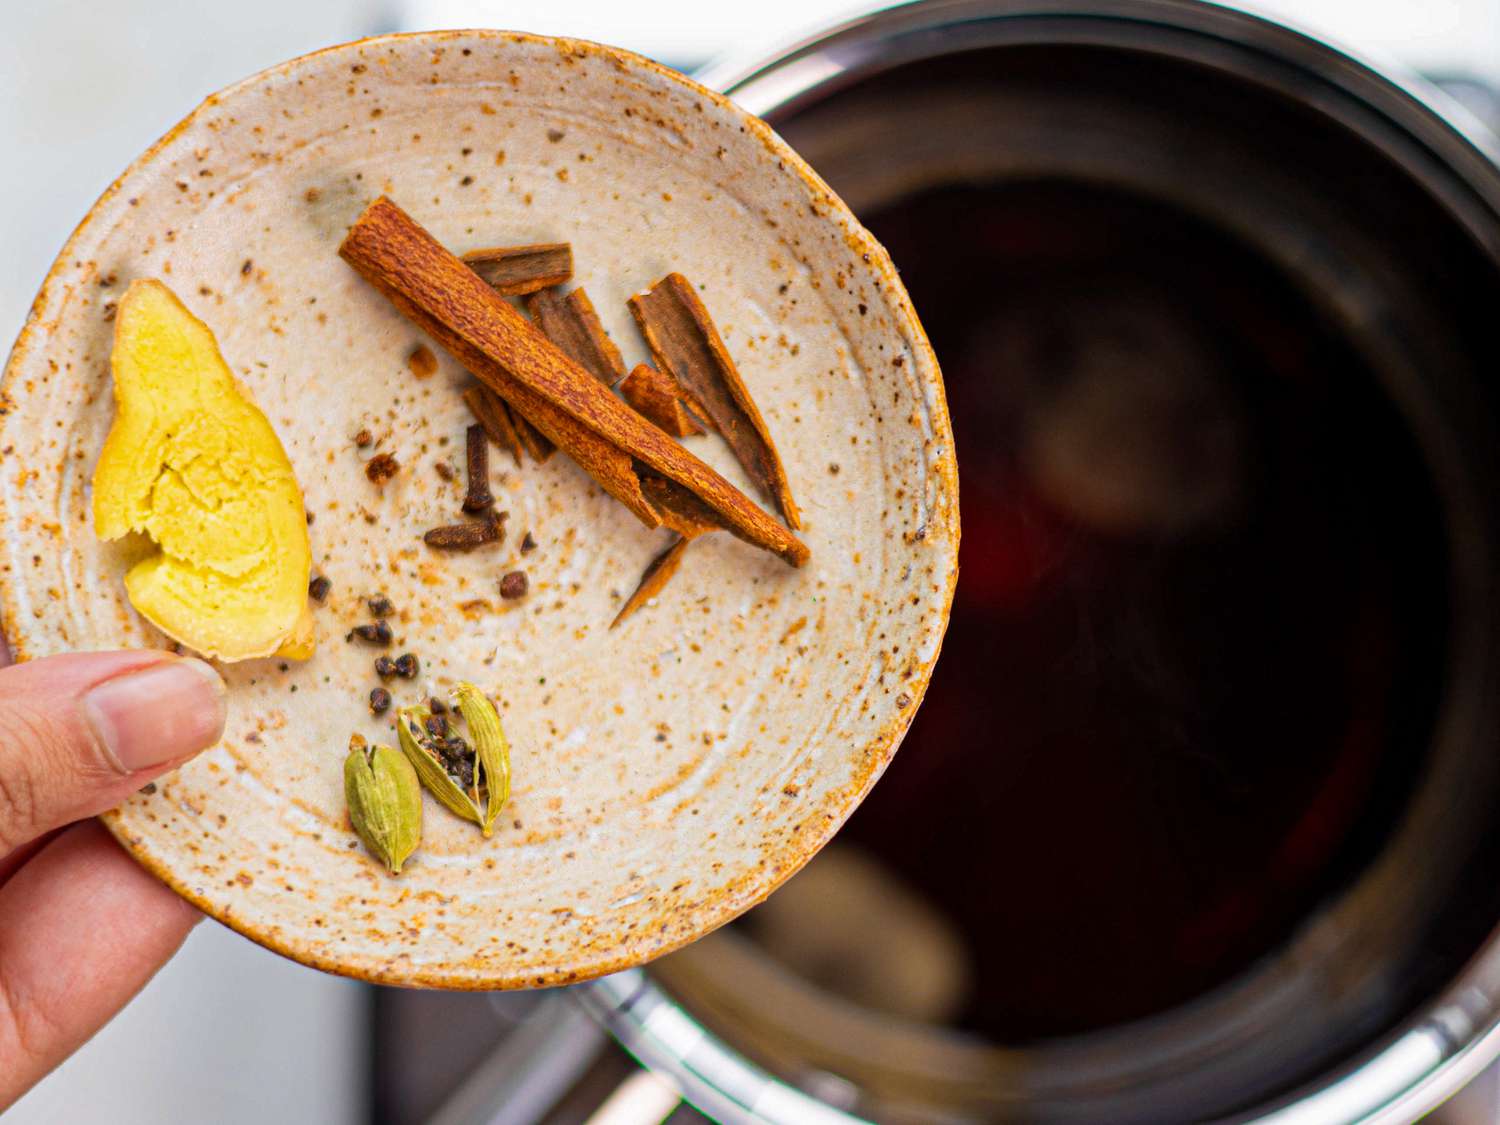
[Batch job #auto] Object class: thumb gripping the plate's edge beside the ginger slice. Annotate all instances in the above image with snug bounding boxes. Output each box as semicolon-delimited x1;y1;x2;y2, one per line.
0;651;225;857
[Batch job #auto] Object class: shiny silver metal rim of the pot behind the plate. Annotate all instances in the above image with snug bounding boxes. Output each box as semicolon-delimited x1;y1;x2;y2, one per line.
585;0;1500;1125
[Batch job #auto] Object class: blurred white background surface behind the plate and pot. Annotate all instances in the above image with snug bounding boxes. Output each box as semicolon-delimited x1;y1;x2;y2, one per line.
0;0;1500;1125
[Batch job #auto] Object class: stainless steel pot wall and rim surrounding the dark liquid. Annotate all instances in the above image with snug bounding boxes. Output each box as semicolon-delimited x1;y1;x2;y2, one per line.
584;0;1500;1125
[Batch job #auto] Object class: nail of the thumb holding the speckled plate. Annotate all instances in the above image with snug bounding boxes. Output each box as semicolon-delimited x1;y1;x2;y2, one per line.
84;657;225;773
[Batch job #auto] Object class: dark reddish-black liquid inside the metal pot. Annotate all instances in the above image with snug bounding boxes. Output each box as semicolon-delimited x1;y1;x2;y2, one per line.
842;183;1448;1043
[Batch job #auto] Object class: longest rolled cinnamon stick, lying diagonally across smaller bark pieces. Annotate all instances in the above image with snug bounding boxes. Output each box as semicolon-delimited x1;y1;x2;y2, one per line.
339;197;809;566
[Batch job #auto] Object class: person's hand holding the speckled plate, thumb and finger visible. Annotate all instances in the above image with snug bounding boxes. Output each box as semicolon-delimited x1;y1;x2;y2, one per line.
0;651;225;1112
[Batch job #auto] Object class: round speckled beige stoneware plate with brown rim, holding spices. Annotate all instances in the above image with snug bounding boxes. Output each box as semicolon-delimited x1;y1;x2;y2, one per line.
0;32;959;989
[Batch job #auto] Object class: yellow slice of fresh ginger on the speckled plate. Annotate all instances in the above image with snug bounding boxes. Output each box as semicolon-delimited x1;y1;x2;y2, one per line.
93;281;315;660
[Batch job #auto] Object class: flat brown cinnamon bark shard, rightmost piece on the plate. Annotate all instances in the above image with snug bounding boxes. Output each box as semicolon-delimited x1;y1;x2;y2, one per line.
630;273;803;530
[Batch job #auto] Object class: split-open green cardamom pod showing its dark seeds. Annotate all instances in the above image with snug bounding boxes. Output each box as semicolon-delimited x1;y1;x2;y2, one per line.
396;684;510;836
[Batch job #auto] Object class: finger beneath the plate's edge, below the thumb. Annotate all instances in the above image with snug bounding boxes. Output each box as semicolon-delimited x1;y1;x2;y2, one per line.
0;821;201;1113
